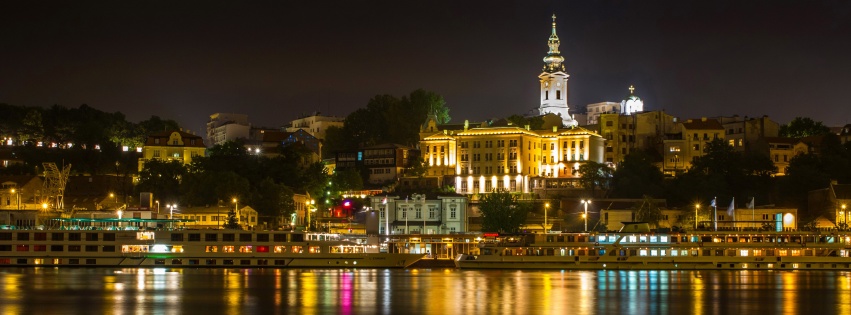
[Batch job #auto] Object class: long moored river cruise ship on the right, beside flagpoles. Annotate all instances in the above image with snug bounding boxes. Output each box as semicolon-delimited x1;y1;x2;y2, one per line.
455;224;851;270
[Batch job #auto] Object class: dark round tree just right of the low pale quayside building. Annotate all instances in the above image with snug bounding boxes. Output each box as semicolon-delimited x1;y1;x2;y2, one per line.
479;189;532;233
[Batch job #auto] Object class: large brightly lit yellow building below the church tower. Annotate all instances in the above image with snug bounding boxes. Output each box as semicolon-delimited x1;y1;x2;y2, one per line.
420;114;604;198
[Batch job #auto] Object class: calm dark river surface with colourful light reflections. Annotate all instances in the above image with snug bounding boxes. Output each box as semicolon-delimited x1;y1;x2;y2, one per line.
0;268;851;315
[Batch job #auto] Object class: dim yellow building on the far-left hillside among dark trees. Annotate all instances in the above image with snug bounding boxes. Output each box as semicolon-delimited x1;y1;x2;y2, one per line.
139;131;207;171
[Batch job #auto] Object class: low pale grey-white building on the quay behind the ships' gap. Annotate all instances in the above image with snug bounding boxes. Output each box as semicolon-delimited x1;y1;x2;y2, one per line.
370;194;468;235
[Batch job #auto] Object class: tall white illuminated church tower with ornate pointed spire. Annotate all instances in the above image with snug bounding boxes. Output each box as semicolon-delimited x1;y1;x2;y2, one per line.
538;14;577;127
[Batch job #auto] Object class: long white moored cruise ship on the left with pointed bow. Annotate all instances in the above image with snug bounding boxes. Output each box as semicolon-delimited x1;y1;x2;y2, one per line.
0;219;425;268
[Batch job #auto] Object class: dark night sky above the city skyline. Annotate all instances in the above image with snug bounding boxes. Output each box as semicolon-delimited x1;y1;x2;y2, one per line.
0;0;851;132
